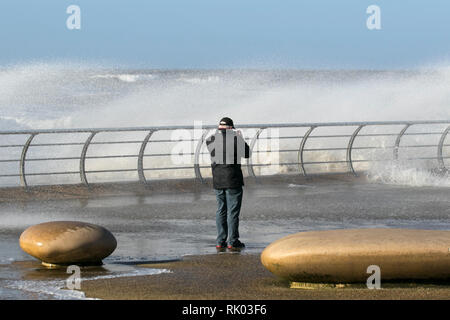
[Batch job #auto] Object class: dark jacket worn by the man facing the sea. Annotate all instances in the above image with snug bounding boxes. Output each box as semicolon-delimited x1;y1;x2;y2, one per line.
206;129;251;189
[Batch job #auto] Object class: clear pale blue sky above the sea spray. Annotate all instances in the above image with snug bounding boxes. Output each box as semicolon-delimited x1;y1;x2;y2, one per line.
0;0;450;69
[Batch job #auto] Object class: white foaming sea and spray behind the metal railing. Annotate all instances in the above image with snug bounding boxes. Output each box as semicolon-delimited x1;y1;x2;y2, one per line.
0;63;450;185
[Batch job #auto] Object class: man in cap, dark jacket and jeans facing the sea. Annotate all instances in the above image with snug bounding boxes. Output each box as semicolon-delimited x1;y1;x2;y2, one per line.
206;117;250;250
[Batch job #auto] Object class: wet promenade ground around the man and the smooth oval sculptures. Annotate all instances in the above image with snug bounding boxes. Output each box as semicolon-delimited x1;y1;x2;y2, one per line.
0;175;450;300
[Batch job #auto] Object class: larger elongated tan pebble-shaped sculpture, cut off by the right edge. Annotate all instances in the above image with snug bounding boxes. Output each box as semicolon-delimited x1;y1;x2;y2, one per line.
261;229;450;283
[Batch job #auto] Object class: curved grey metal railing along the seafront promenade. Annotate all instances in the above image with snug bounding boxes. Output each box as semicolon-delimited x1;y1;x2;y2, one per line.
0;120;450;187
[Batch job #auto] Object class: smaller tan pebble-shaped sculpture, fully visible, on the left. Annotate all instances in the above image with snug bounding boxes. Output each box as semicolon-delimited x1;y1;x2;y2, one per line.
19;221;117;265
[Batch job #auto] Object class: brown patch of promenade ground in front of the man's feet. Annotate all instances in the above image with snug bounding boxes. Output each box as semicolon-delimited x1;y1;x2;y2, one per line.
81;251;450;300
